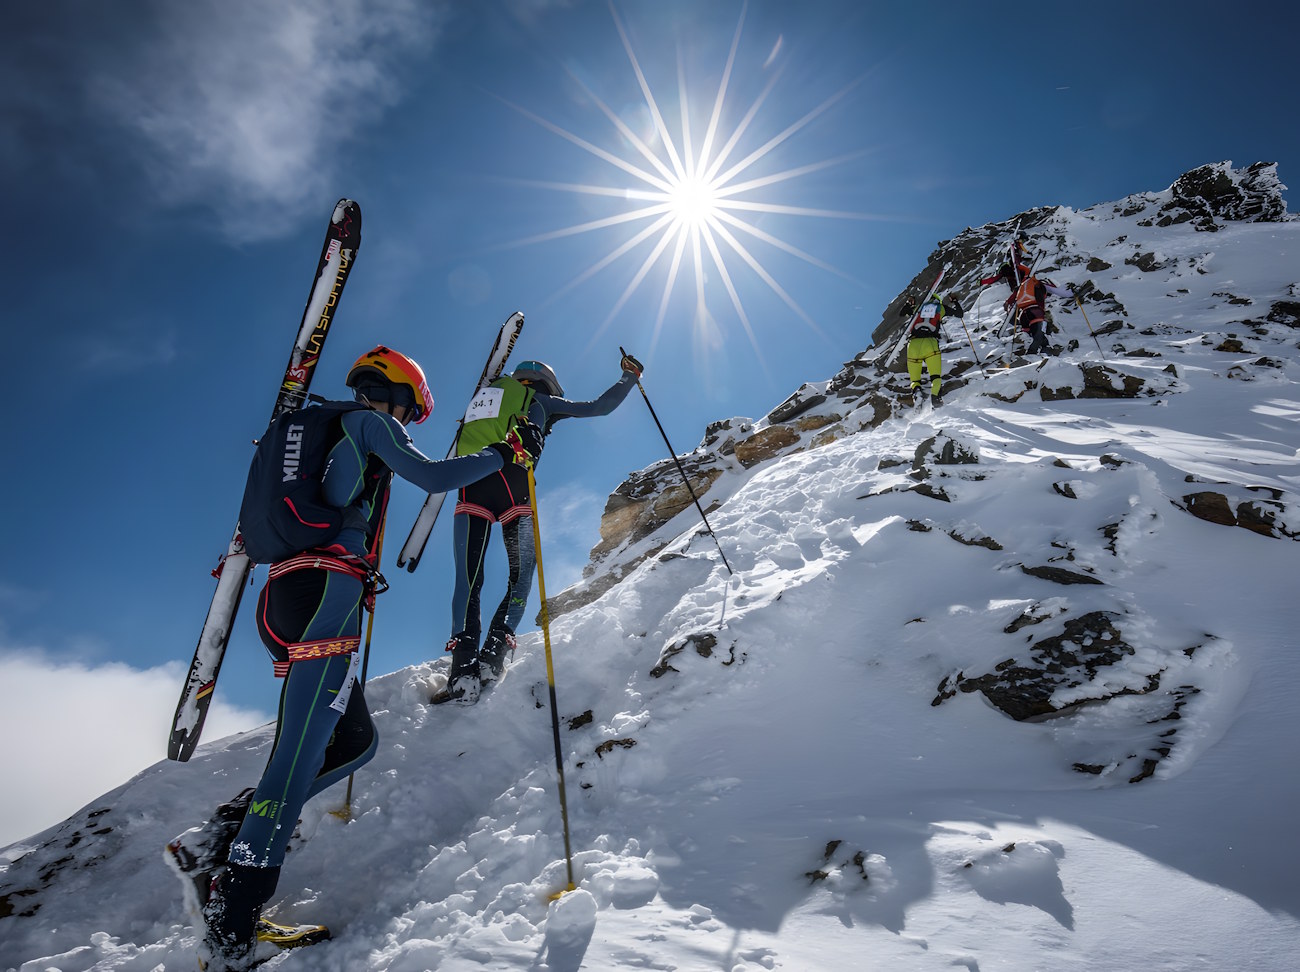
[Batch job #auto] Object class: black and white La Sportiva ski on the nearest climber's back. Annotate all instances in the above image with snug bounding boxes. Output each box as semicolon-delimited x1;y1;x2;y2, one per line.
168;199;361;761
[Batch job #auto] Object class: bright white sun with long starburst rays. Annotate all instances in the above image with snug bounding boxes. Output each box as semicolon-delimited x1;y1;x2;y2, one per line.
491;3;887;361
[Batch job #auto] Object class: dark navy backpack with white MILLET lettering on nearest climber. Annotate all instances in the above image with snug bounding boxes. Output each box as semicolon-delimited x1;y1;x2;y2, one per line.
239;402;365;564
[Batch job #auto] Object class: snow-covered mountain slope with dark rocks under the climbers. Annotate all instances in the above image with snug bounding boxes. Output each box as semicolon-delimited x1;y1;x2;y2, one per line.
0;163;1300;972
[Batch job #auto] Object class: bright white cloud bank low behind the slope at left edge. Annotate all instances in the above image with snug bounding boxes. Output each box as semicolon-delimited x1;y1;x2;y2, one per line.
0;651;273;847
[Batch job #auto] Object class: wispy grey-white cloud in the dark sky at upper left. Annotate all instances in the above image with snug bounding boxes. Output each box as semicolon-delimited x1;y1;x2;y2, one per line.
88;0;445;239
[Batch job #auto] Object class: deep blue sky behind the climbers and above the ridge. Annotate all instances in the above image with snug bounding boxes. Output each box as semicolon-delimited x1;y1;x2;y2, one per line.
0;0;1300;754
